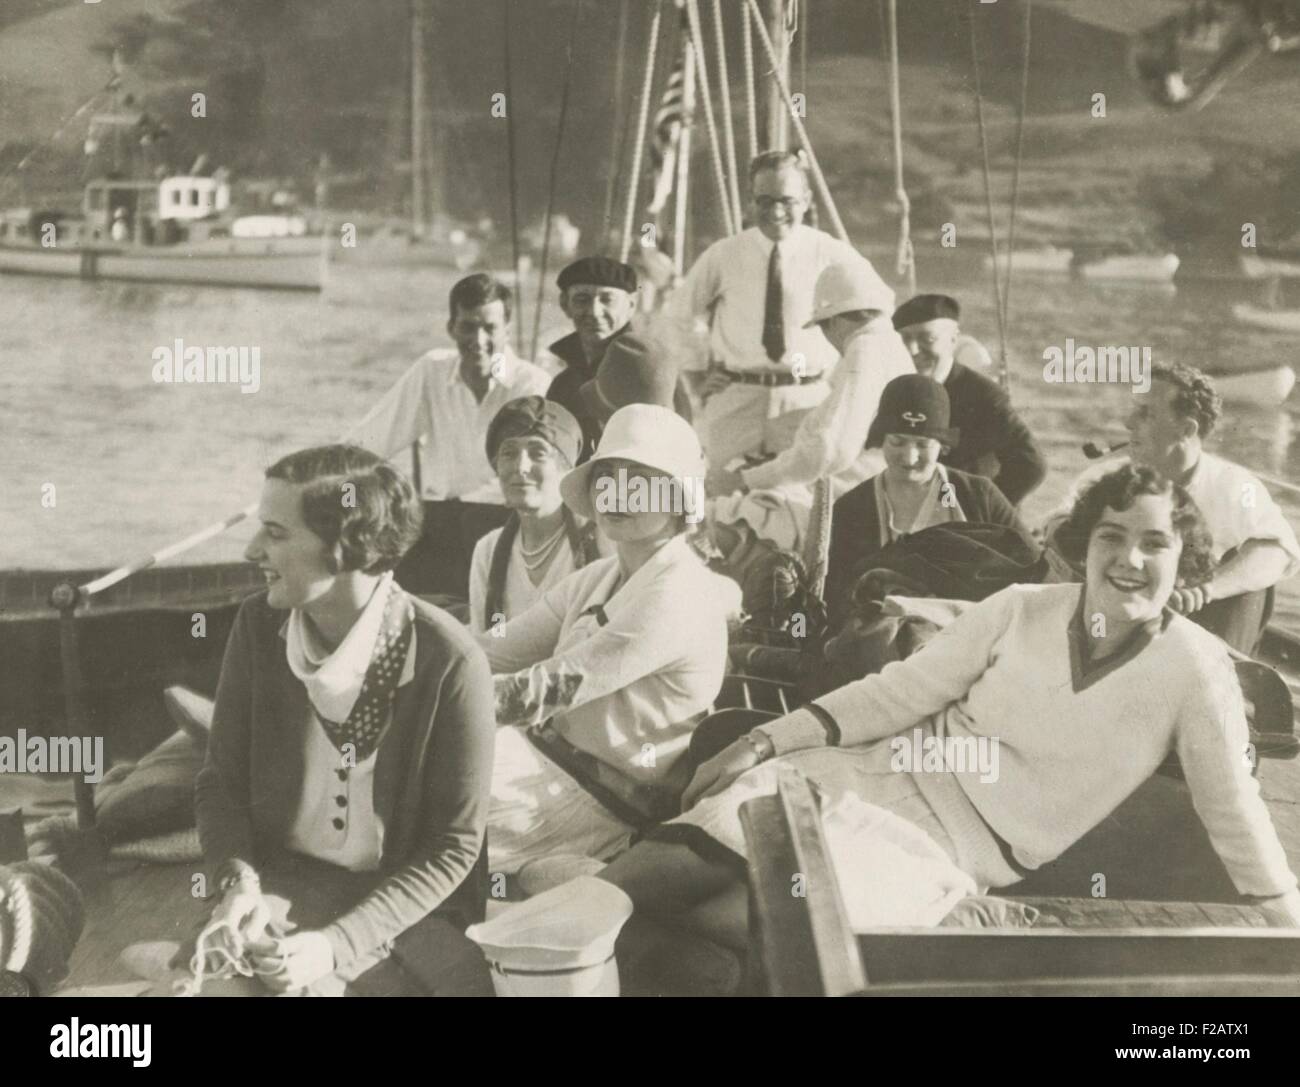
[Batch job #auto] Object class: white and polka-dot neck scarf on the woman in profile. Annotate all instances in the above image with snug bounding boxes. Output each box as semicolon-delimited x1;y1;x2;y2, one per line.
286;575;415;765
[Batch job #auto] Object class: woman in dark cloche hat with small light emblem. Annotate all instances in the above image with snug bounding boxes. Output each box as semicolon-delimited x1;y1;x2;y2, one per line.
826;373;1031;611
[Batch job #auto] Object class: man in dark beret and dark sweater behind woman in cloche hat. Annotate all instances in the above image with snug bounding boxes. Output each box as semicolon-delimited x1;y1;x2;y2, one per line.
893;294;1047;506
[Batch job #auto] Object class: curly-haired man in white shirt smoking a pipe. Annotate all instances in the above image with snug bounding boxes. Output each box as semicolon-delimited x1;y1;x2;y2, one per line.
1048;363;1300;653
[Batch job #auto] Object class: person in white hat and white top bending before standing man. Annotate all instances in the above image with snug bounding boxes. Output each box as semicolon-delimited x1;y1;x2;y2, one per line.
709;256;915;547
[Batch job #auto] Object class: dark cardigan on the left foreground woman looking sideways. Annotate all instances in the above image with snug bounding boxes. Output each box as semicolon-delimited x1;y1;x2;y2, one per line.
195;593;495;969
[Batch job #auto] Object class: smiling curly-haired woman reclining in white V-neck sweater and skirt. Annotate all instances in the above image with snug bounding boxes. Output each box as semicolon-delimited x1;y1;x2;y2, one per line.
601;465;1300;940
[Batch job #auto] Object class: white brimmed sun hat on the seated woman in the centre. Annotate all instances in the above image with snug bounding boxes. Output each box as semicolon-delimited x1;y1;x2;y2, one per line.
560;404;705;523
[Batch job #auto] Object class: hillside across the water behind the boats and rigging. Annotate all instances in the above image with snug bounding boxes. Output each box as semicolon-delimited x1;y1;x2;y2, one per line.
0;0;1300;257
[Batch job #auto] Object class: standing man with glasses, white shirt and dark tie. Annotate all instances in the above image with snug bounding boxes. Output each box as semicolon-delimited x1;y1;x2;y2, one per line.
670;151;863;468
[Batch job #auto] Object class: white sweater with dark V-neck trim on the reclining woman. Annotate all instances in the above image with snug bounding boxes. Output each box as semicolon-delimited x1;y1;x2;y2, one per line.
762;585;1296;896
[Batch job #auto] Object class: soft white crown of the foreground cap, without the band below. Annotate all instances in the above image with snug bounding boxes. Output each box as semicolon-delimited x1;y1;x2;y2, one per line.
465;875;632;973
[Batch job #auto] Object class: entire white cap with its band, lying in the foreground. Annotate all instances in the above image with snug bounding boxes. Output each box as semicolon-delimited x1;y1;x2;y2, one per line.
465;875;632;996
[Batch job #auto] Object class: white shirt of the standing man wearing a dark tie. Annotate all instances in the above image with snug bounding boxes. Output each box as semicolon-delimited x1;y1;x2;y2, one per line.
668;224;866;374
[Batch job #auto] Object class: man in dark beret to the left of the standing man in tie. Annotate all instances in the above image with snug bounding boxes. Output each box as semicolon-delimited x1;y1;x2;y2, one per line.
546;256;637;460
